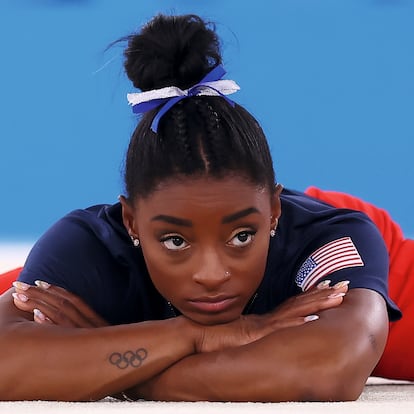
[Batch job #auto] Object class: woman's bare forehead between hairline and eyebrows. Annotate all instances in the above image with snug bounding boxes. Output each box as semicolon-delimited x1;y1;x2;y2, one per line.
138;177;270;213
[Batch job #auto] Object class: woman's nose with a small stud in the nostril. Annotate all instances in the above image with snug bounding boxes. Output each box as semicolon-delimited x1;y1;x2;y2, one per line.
193;251;231;290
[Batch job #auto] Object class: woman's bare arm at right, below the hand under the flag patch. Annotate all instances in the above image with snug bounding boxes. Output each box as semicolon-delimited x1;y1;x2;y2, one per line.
137;292;387;401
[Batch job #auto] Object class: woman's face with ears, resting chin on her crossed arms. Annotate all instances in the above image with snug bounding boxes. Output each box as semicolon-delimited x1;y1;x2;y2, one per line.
123;177;280;324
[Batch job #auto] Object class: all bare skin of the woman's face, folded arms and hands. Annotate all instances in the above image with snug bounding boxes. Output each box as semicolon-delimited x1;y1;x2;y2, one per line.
0;178;388;401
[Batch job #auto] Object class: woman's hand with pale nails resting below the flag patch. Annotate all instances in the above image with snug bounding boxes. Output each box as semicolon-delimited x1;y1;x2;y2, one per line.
196;280;349;352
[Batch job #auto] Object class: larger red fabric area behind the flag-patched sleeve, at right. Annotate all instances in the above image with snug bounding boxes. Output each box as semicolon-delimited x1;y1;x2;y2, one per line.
305;187;414;380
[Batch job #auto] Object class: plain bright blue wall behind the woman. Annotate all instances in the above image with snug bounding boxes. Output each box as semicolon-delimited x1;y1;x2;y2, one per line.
0;0;414;241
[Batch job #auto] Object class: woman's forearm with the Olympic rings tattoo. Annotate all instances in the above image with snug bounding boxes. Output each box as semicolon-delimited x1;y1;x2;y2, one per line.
0;302;194;401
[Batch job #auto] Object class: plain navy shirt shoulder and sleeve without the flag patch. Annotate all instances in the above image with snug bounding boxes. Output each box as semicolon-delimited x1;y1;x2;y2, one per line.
19;204;157;324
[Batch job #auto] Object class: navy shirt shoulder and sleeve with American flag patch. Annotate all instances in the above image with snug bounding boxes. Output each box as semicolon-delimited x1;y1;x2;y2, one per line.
269;190;398;317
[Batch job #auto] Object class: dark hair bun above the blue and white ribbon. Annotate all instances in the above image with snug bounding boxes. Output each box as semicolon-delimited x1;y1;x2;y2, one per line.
124;14;221;91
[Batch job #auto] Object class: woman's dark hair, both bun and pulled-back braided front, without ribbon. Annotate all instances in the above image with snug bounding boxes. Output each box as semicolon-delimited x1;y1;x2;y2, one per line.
120;15;275;200
